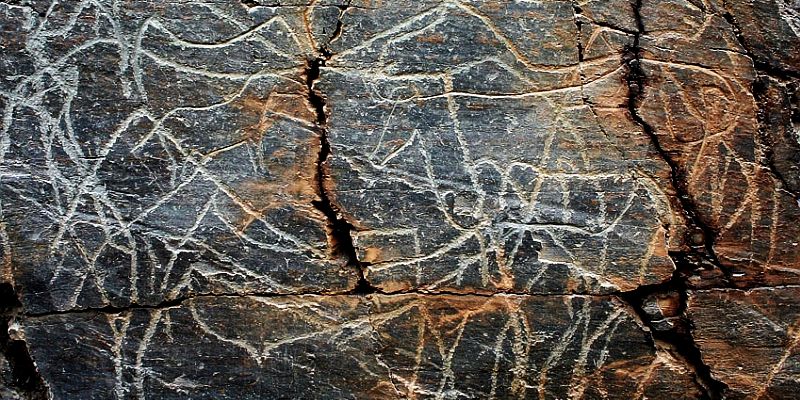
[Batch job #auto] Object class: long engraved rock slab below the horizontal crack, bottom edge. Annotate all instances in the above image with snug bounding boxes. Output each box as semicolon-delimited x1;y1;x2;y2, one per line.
21;295;700;399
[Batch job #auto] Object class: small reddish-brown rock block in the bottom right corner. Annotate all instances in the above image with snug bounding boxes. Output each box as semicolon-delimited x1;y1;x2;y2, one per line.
689;286;800;399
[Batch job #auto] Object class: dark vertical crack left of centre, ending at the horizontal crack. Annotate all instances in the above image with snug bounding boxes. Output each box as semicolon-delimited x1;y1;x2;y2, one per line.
305;50;378;295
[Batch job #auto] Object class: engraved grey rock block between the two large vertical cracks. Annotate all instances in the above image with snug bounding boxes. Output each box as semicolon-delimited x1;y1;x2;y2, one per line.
318;2;682;293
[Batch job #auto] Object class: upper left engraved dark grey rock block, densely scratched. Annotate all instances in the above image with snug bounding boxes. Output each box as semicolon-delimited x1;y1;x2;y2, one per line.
0;2;355;312
